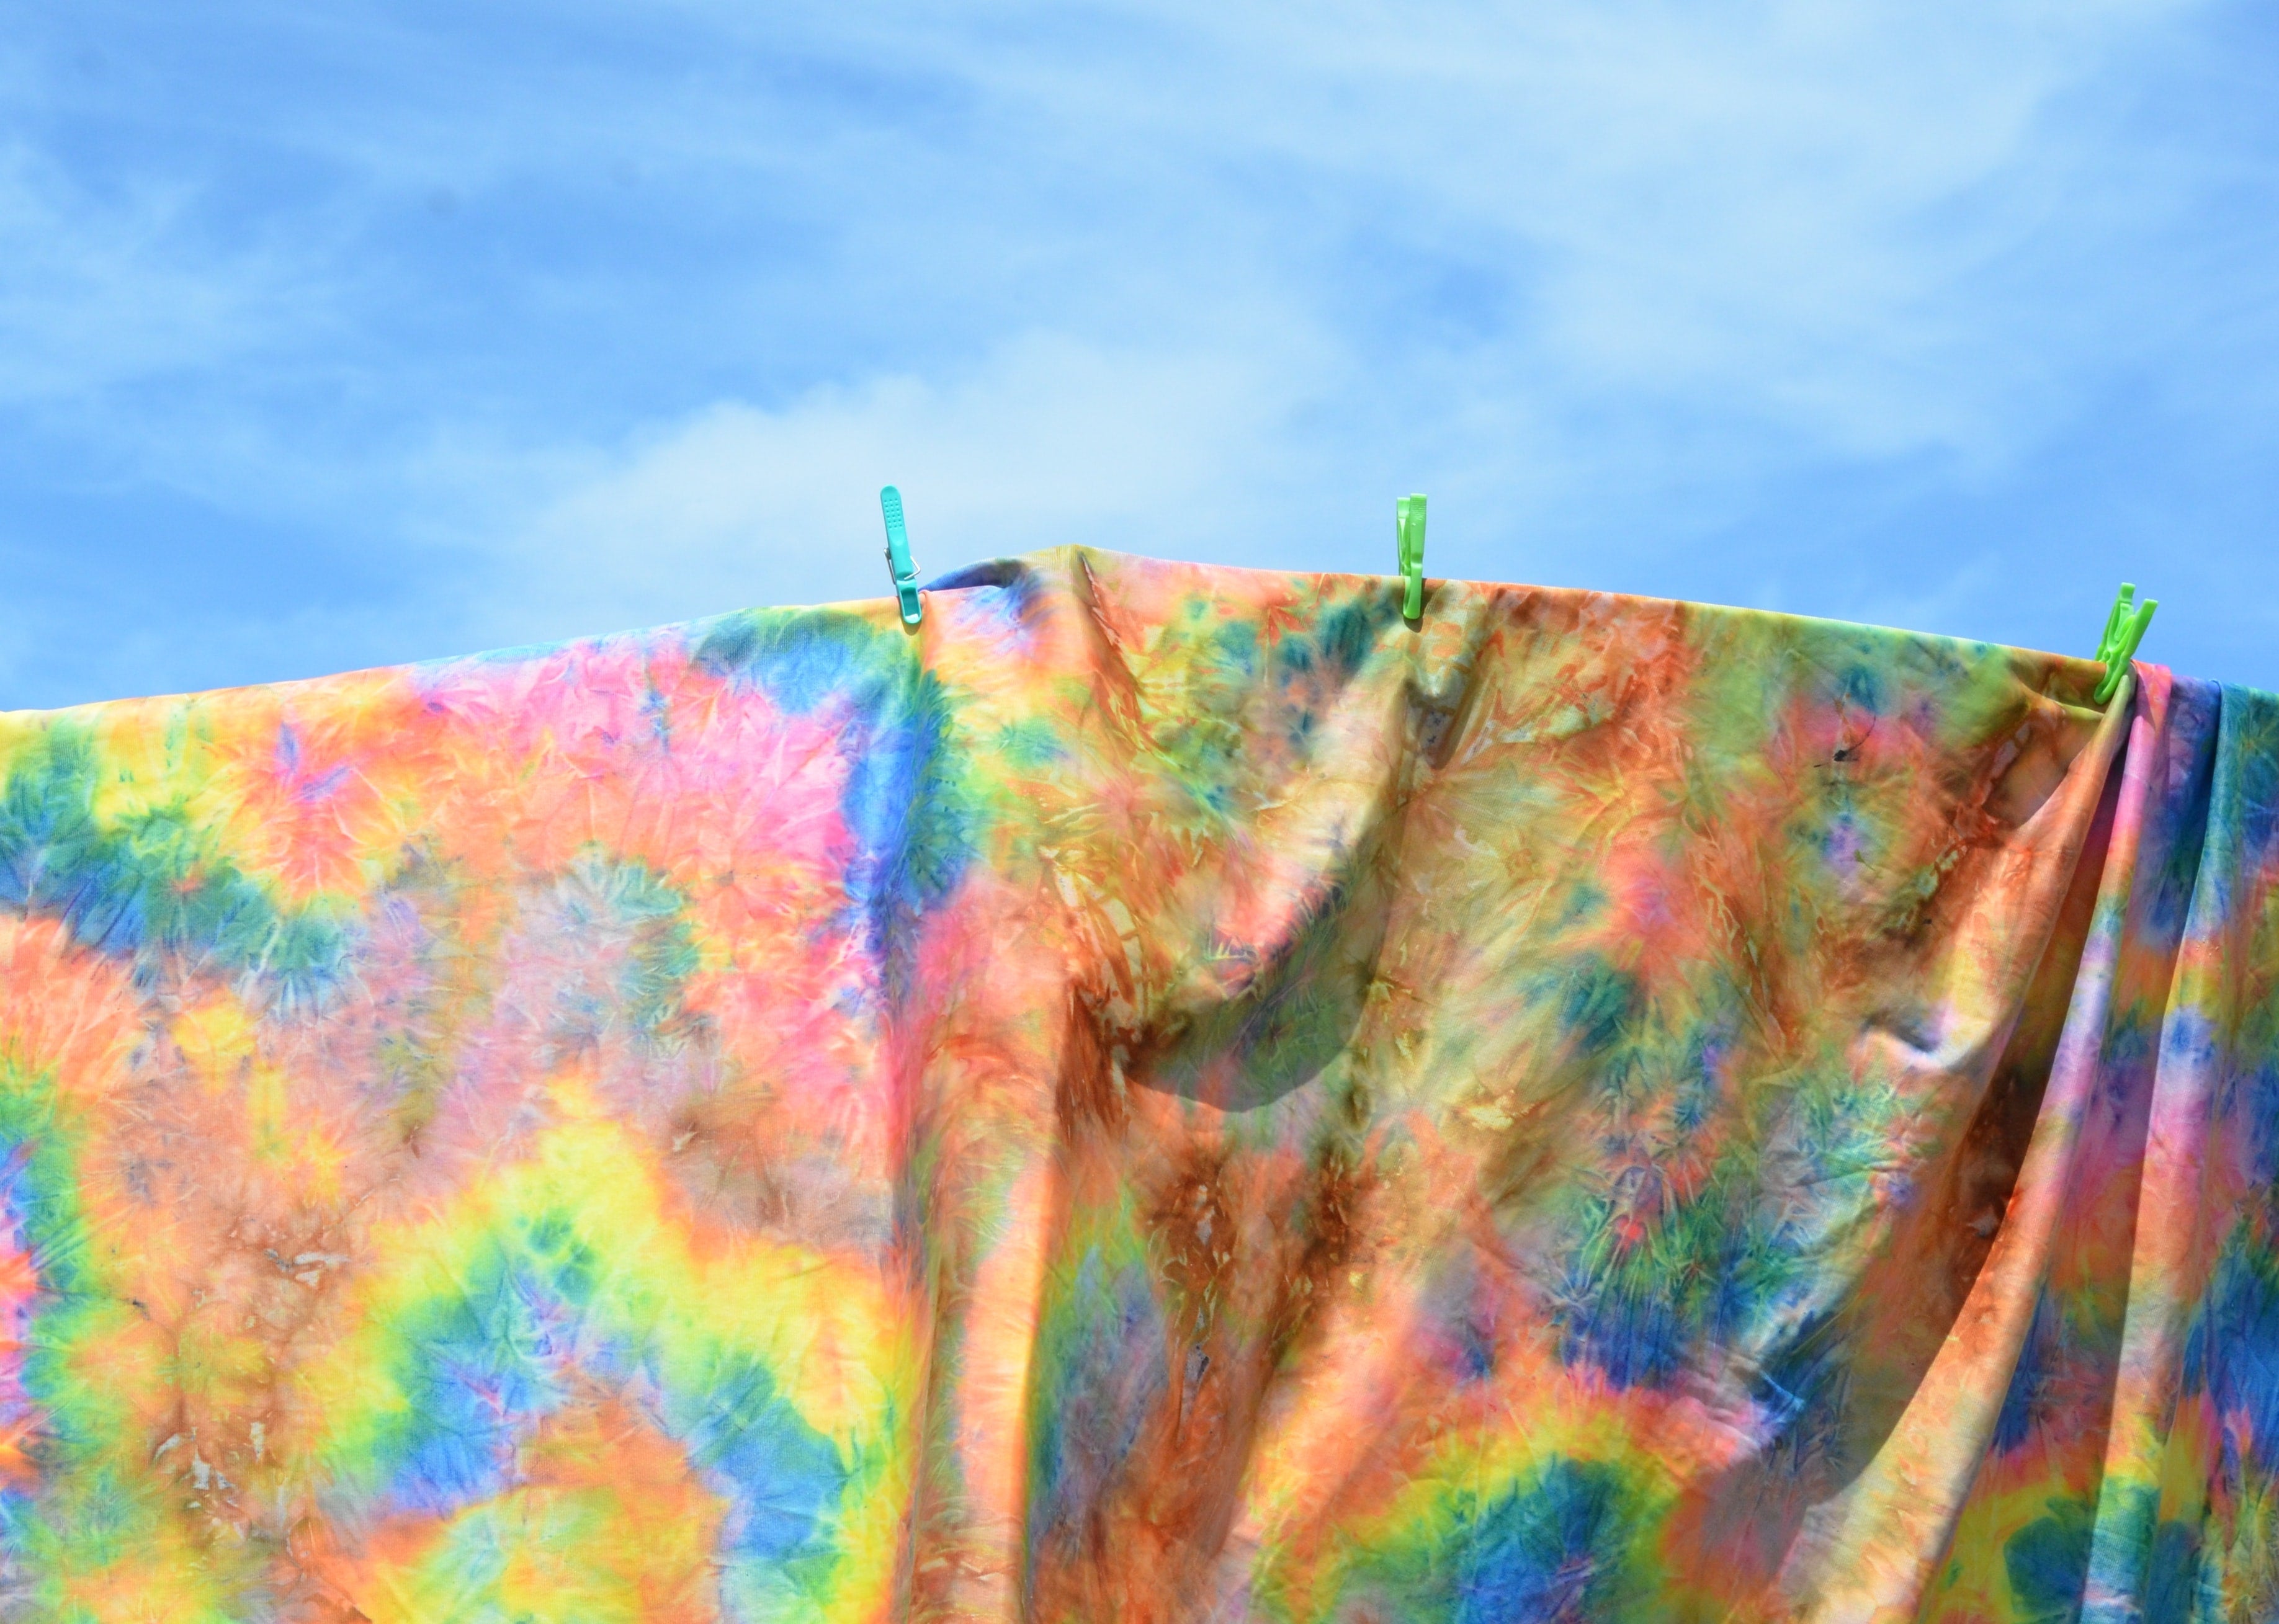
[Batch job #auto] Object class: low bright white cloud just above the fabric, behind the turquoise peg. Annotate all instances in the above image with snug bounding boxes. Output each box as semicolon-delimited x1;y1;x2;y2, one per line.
453;332;1331;640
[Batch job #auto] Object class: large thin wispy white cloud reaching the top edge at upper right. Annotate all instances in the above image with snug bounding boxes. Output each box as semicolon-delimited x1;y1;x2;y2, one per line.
875;0;2185;458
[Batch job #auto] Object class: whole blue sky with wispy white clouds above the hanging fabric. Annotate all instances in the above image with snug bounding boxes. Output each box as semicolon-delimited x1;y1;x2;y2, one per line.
0;0;2279;706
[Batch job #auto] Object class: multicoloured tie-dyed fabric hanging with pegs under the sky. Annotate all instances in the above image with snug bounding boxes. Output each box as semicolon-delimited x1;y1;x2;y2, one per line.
0;549;2279;1624
